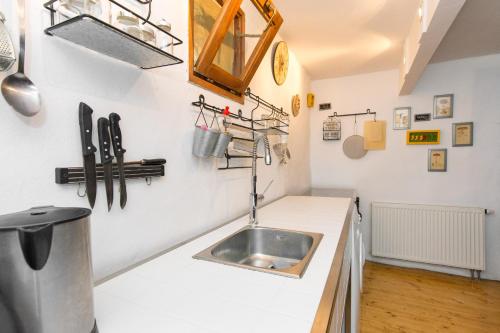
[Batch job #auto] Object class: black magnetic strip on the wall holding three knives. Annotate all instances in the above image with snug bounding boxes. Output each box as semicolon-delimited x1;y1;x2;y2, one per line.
56;163;165;184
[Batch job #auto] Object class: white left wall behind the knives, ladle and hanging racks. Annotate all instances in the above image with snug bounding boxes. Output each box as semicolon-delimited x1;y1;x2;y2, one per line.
0;0;310;279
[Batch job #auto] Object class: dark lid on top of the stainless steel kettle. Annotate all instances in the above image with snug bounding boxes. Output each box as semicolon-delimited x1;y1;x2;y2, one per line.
0;206;92;231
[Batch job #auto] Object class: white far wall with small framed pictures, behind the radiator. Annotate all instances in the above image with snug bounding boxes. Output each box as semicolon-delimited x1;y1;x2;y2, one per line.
311;55;500;280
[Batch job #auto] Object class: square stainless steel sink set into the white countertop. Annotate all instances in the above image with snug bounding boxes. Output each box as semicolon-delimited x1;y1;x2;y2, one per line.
193;226;323;279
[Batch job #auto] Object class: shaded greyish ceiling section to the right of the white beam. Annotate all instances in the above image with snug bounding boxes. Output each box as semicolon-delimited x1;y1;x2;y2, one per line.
431;0;500;62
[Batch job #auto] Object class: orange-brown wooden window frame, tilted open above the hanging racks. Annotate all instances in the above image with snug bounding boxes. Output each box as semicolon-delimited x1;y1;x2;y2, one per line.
189;0;283;104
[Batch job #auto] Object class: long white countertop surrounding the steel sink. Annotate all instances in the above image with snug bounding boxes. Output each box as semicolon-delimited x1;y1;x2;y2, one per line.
95;197;350;333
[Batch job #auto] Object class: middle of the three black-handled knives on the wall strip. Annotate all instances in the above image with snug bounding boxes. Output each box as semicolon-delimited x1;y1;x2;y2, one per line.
97;118;113;212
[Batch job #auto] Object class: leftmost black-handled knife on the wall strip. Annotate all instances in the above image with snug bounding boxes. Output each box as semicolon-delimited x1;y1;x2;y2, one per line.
78;103;97;208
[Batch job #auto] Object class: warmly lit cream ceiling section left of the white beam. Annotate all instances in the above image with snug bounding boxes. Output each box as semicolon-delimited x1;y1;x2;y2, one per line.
274;0;420;79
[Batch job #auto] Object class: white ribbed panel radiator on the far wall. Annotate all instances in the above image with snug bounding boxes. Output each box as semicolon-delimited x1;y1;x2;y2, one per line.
372;202;485;271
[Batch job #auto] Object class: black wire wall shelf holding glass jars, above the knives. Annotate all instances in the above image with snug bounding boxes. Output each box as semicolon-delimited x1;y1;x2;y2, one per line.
43;0;183;69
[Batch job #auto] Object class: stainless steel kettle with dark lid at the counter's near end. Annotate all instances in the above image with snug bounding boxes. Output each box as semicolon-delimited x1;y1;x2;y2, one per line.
0;206;97;333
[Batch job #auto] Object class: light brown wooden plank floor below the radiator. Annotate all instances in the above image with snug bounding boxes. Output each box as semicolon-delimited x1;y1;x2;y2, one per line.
361;262;500;333
